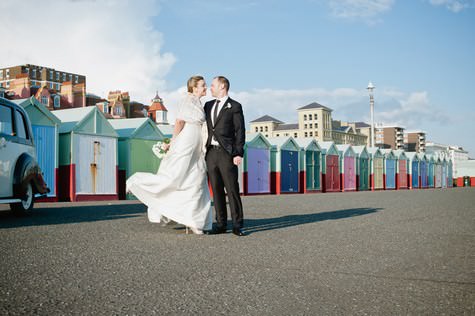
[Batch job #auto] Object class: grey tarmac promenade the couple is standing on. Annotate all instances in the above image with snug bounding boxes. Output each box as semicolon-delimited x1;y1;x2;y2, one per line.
0;188;475;315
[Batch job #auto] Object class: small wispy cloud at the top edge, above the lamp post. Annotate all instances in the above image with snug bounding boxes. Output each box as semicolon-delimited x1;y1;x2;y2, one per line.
328;0;395;23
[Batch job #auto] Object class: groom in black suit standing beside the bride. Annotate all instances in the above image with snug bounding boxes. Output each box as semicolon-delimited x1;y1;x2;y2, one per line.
204;76;245;236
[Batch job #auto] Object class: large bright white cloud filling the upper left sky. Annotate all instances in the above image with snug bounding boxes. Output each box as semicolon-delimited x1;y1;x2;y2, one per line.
0;0;176;103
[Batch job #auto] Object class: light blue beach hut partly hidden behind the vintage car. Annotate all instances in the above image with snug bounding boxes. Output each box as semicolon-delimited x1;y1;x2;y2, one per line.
13;97;61;202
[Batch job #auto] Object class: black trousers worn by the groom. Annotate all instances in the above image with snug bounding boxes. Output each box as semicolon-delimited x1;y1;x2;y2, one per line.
206;146;244;228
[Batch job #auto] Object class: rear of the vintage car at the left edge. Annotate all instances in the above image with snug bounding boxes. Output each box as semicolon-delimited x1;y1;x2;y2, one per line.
0;97;49;214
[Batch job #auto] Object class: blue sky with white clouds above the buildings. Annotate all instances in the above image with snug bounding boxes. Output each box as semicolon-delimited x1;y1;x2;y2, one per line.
0;0;475;158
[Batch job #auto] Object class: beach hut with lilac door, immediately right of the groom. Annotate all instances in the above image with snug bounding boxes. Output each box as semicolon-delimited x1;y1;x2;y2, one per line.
244;133;272;195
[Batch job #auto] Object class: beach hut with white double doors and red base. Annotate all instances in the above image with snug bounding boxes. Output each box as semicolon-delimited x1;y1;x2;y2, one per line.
54;106;118;201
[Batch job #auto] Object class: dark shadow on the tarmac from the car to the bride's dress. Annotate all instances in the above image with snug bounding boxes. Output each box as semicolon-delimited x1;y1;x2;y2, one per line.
0;204;147;229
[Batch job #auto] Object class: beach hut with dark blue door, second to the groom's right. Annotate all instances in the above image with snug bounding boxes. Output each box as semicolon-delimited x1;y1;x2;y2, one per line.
267;137;300;194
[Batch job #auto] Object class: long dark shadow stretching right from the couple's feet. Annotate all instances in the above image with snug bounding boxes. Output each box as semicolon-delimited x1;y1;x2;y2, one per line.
242;208;383;234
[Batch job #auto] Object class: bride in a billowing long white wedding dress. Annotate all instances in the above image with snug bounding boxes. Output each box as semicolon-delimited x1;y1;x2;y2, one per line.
126;76;212;234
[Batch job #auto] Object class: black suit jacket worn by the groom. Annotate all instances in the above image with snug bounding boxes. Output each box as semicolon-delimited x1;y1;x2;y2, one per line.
204;97;246;157
